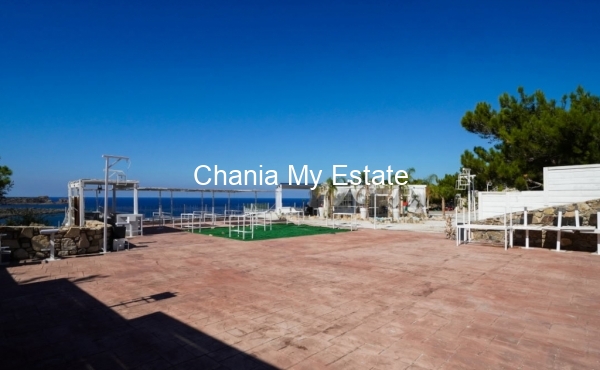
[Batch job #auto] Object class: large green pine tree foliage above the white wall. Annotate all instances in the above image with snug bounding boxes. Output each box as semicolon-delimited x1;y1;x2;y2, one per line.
461;87;600;190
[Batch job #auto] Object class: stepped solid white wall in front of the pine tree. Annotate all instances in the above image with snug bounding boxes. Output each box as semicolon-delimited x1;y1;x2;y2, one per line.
477;164;600;220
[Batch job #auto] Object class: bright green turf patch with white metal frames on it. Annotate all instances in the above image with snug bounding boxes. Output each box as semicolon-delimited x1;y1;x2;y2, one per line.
192;224;350;241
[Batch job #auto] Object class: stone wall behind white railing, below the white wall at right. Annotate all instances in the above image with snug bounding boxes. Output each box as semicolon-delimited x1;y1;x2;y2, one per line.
472;199;600;252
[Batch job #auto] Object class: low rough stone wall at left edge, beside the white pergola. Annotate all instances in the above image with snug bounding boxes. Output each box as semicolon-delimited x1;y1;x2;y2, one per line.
0;221;112;261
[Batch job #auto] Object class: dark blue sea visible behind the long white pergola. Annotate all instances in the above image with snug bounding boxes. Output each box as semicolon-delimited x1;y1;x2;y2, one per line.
0;196;308;226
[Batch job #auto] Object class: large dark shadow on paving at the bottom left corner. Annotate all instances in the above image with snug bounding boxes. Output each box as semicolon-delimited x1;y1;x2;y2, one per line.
0;267;275;369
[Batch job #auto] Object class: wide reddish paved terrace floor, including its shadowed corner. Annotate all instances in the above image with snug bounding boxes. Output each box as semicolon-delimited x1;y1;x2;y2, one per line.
0;230;600;370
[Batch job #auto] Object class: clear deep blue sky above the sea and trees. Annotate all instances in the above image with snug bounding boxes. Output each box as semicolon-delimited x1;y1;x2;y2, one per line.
0;0;600;196
